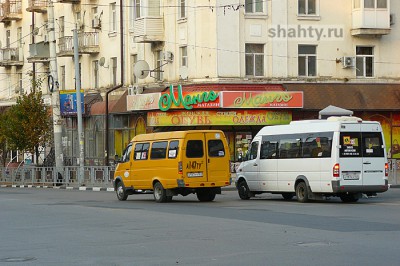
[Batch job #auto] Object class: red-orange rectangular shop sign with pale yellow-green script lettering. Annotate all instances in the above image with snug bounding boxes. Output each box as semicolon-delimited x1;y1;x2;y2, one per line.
221;91;303;108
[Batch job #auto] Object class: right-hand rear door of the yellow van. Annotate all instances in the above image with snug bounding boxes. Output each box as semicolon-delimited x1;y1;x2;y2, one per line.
205;132;230;182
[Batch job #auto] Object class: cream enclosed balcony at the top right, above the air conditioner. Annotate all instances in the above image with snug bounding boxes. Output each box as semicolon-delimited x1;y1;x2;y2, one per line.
351;8;390;37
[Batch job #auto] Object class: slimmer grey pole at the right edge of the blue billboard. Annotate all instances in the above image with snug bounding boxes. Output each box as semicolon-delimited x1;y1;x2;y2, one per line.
73;27;85;184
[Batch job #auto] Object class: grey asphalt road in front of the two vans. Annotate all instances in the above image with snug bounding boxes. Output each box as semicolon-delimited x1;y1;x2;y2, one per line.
0;188;400;266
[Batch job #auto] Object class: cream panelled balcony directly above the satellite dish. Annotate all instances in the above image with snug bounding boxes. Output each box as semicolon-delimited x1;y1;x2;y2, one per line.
133;17;164;43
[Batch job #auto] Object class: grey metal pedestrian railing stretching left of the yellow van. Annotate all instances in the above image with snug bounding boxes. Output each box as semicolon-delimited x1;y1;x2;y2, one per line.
0;165;115;187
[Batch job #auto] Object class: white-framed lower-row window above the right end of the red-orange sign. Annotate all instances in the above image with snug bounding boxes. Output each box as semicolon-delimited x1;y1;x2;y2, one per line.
298;45;317;77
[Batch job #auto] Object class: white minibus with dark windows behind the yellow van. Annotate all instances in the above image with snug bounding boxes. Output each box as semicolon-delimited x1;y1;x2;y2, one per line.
236;117;388;202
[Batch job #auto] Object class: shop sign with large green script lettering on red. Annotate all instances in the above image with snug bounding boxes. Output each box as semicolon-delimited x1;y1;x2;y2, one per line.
158;85;220;112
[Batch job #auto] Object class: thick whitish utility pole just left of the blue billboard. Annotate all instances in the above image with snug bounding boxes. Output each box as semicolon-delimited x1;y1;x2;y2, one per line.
47;0;64;172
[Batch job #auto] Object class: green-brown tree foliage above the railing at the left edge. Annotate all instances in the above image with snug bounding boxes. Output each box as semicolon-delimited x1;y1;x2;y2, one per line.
0;91;52;153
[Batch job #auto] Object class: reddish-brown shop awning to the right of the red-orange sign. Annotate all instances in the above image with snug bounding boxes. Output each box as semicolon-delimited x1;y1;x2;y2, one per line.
284;83;400;111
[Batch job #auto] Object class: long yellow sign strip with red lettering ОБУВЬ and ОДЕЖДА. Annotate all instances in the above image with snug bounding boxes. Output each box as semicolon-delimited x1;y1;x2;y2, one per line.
147;110;292;126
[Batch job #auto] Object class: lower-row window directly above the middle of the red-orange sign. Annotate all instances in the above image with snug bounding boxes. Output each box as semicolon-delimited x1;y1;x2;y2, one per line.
245;43;264;77
